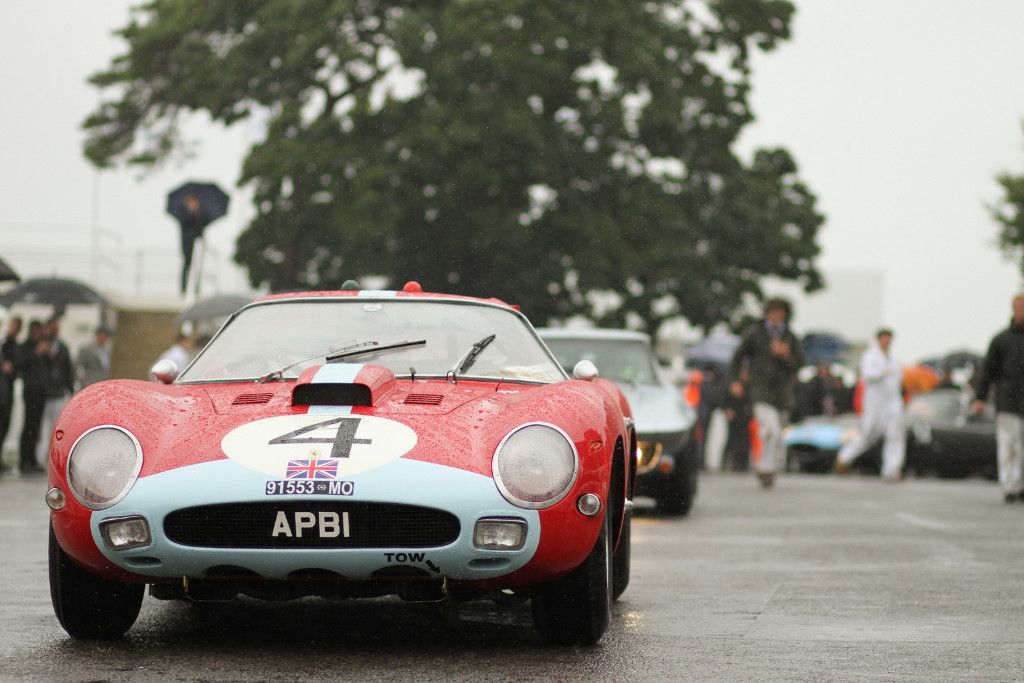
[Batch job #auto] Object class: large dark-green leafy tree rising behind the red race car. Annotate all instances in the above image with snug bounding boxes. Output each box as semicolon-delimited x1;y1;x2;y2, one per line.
85;0;823;330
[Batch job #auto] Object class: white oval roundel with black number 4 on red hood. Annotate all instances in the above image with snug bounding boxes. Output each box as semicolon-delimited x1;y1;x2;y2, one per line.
220;414;416;479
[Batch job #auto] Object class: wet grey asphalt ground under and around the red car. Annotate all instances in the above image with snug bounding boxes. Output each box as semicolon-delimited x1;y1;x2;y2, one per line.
0;473;1024;681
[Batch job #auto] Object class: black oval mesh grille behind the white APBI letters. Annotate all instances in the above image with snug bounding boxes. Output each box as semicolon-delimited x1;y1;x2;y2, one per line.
164;501;460;548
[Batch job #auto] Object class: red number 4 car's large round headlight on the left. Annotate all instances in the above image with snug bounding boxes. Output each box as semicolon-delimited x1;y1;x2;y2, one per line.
68;425;142;510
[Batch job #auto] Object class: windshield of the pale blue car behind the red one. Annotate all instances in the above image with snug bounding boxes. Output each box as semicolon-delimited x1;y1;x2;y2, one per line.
545;338;658;384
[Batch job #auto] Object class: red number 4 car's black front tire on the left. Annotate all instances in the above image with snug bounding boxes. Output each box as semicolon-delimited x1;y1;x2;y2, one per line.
49;525;145;640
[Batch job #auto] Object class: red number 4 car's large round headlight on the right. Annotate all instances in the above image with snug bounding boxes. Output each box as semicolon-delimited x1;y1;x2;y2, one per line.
494;423;579;509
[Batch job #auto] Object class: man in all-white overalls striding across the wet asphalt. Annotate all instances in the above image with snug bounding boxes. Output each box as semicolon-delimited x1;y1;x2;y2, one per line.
836;330;906;481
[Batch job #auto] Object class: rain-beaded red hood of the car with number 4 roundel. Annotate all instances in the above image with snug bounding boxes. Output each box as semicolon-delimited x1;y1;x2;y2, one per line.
54;365;622;478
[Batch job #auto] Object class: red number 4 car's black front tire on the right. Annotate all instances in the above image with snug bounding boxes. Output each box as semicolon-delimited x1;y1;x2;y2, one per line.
532;512;612;645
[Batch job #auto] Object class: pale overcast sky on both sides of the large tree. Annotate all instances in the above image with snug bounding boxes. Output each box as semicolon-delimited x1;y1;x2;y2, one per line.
0;0;1024;358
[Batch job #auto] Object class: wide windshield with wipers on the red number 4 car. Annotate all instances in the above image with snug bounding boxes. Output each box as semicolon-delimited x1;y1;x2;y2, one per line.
178;297;564;383
